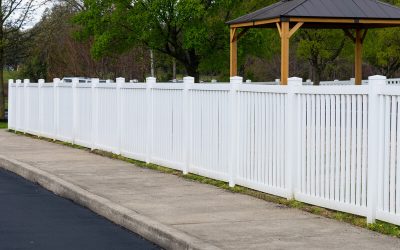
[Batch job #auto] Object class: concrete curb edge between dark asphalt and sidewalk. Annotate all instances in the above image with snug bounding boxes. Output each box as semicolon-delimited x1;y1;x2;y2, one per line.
0;155;220;250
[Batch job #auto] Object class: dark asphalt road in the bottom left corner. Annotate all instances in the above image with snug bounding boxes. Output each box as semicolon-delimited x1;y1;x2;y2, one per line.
0;169;160;250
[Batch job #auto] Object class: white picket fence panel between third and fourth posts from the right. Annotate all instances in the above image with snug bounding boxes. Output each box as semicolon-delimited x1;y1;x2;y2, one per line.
189;84;231;181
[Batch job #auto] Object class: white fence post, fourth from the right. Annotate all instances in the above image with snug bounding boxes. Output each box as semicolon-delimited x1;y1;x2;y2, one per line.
182;76;194;174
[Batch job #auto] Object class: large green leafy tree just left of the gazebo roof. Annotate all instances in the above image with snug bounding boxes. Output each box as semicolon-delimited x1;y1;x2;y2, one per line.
75;0;275;80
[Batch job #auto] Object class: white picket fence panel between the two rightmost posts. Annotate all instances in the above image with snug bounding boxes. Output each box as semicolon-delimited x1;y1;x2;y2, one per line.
295;86;368;216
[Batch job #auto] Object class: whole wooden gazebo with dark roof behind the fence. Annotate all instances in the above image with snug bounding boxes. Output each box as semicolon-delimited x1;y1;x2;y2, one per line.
227;0;400;85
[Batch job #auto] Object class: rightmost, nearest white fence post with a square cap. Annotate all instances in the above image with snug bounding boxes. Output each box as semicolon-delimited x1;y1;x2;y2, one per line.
367;75;386;223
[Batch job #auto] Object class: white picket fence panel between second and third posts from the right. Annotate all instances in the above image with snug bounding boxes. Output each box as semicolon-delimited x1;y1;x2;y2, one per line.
236;86;286;196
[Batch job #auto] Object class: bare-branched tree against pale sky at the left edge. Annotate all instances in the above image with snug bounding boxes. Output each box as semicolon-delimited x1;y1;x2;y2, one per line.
0;0;41;119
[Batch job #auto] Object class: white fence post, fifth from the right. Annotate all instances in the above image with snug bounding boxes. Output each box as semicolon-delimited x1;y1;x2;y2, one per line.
146;77;157;164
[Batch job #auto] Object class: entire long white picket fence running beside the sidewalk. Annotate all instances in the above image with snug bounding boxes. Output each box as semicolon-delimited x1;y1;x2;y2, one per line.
9;76;400;225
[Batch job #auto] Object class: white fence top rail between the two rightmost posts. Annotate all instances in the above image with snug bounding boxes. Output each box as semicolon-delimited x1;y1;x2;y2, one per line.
295;85;368;95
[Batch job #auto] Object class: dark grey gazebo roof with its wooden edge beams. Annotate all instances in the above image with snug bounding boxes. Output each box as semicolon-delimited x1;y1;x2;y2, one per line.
228;0;400;28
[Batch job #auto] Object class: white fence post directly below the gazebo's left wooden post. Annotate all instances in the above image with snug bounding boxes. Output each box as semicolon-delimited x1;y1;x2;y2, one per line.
229;76;243;187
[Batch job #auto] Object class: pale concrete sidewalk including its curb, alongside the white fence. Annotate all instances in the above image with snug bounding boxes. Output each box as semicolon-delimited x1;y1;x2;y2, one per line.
0;130;400;249
